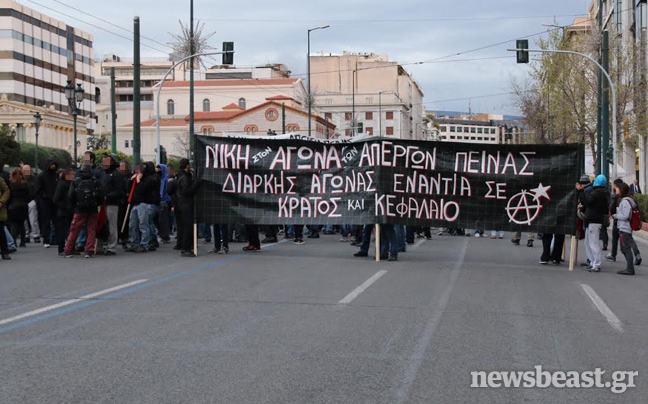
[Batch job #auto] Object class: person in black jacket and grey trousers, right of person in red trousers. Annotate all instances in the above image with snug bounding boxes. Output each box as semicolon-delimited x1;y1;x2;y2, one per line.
101;155;124;255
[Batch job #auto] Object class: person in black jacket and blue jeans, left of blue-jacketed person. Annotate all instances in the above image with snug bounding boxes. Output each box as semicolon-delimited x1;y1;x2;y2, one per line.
126;161;160;253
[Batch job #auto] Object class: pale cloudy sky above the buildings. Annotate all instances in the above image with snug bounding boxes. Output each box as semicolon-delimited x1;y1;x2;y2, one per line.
26;0;590;114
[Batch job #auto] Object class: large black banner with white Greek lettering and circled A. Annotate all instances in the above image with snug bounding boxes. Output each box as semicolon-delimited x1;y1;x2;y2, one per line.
194;136;583;234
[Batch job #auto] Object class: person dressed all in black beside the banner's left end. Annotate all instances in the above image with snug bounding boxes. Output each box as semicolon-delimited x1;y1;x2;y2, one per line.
175;159;201;257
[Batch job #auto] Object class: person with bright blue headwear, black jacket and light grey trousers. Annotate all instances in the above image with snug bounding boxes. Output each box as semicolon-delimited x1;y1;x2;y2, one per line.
579;175;610;272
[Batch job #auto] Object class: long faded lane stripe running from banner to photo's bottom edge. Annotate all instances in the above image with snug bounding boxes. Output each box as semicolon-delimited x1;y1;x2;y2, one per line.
394;237;469;404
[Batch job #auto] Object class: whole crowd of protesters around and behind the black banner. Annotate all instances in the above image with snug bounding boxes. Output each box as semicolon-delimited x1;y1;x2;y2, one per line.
0;151;642;275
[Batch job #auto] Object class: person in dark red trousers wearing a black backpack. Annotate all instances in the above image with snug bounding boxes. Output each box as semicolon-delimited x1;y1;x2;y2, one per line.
64;162;104;258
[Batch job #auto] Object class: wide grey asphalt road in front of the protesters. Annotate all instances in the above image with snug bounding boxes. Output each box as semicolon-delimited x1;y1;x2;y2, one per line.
0;235;648;404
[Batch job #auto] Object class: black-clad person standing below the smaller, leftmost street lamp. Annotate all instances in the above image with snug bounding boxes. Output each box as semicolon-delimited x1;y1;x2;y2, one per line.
35;159;59;248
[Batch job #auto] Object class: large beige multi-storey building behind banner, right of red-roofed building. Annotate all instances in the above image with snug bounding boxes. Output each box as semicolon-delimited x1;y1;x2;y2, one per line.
310;52;427;140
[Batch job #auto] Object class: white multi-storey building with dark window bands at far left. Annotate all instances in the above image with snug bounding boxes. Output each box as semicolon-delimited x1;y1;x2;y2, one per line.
0;0;96;155
